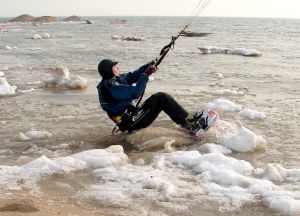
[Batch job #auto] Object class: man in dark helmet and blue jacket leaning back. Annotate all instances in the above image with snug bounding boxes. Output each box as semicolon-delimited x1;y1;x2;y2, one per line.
97;59;212;134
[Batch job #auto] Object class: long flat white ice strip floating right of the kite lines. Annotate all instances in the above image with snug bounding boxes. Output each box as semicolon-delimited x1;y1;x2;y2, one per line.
199;46;262;57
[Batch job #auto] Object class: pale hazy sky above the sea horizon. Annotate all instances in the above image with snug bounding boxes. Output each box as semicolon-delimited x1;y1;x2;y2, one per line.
0;0;300;18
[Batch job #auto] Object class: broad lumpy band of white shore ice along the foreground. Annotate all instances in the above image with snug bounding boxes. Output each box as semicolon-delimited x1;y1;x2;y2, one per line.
0;146;300;215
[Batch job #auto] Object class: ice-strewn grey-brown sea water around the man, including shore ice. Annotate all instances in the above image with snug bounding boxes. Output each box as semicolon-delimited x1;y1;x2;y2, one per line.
0;17;300;215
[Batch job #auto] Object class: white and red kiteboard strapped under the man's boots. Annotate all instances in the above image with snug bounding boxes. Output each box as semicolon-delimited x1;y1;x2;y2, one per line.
193;109;219;140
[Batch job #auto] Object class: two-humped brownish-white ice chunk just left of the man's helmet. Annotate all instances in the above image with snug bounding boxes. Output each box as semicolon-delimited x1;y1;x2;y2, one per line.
45;66;88;89
